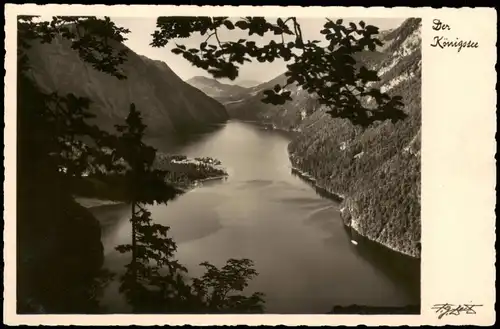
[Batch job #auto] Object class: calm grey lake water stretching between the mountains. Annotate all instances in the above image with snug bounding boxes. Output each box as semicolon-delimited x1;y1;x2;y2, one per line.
94;121;419;313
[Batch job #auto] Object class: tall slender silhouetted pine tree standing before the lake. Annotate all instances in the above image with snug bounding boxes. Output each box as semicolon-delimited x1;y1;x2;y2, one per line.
109;104;185;312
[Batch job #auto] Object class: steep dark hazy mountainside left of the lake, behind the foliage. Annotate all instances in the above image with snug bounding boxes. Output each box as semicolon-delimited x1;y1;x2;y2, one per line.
24;38;228;135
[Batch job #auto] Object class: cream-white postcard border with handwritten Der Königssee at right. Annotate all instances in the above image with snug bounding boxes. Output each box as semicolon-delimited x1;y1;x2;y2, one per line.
4;4;497;325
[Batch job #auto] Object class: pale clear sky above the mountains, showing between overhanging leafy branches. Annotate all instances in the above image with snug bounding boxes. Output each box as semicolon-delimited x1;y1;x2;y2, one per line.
111;17;405;84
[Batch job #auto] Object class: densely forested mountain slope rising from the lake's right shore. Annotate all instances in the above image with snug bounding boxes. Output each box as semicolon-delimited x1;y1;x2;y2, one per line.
229;18;422;258
